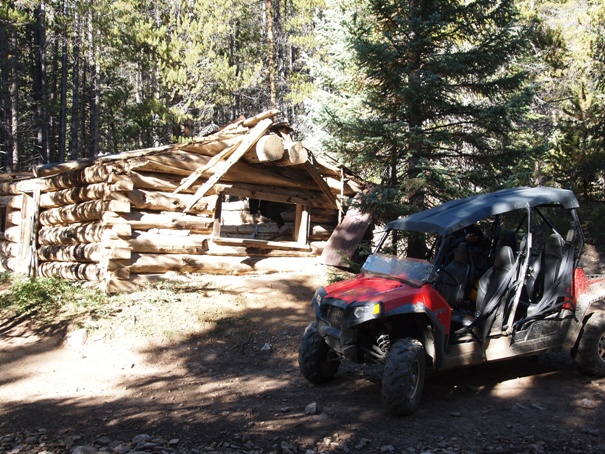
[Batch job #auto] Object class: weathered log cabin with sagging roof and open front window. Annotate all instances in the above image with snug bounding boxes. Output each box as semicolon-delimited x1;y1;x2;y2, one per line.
0;111;361;292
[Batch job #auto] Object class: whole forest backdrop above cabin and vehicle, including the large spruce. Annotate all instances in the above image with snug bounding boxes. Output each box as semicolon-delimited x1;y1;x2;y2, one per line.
0;0;605;244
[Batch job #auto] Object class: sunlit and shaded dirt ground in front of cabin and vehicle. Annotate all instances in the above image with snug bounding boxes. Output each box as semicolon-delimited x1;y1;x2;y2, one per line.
0;250;605;454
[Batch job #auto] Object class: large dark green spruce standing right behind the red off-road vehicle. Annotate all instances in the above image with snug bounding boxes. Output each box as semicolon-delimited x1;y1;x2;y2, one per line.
313;0;532;224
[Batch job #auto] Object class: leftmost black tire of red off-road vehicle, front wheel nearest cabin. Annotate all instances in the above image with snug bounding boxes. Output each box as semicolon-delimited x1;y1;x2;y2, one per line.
298;322;340;385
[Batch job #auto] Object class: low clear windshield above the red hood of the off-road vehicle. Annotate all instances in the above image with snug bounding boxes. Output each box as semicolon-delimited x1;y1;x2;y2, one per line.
361;253;434;287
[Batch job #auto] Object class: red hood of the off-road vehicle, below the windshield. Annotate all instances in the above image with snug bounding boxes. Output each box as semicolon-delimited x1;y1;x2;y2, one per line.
325;277;418;304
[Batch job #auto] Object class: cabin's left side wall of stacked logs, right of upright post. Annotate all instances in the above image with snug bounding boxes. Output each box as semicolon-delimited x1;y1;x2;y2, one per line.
37;164;133;284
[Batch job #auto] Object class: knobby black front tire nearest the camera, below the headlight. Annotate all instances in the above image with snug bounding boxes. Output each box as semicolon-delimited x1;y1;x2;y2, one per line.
382;338;426;415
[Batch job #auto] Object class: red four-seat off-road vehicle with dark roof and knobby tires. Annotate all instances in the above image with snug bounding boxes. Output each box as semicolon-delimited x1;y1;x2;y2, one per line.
299;187;605;415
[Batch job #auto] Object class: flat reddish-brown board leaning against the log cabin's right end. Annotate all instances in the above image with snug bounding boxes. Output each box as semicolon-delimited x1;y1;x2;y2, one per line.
319;194;371;267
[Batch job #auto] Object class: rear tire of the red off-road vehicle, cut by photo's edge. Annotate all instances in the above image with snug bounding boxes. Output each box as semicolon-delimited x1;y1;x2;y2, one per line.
574;313;605;377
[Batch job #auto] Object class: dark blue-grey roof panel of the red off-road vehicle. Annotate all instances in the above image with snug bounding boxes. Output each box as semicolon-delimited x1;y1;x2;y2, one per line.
387;187;579;235
